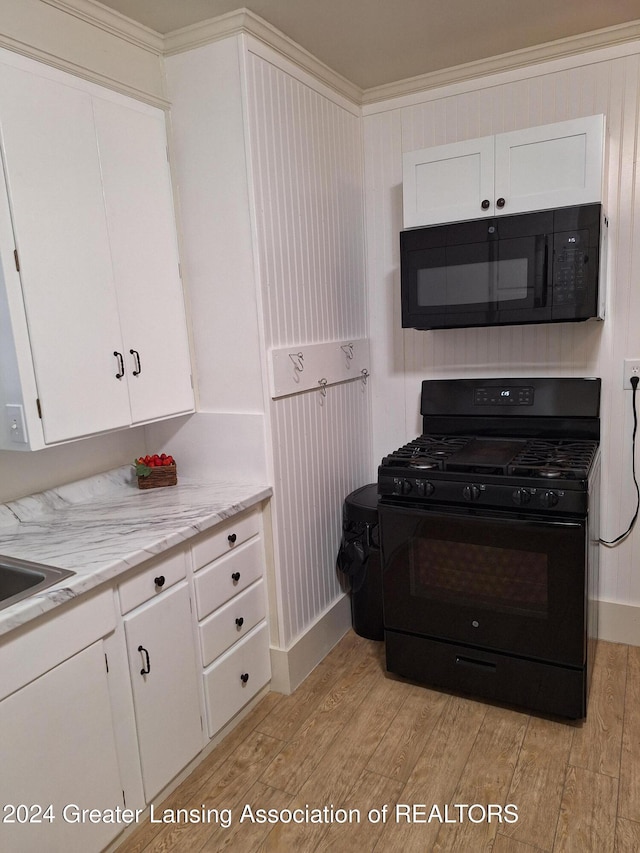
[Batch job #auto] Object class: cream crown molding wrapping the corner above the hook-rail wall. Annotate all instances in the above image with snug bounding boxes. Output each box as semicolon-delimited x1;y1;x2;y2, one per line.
164;9;363;105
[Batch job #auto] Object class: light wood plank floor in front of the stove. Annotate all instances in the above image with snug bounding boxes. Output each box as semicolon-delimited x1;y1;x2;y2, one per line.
118;632;640;853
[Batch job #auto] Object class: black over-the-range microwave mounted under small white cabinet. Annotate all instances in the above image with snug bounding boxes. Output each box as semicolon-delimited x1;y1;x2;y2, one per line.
400;204;607;329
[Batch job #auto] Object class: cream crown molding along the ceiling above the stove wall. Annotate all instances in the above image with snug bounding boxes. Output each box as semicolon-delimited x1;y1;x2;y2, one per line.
360;20;640;106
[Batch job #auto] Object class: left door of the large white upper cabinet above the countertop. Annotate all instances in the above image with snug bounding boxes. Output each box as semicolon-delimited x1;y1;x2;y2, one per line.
0;65;130;443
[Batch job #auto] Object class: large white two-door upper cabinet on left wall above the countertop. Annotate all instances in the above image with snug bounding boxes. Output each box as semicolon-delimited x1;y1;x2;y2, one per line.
0;53;193;450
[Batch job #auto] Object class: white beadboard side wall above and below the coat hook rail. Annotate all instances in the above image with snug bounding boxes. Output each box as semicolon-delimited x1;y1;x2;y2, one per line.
246;51;372;649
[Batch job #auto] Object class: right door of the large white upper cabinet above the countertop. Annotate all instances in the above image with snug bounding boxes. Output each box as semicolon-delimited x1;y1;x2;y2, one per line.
94;98;193;423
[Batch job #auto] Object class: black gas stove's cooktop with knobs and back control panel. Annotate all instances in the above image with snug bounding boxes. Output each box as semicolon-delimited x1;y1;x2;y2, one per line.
378;377;600;515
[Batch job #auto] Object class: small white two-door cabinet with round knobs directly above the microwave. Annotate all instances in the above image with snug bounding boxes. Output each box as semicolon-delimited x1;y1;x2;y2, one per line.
403;115;604;228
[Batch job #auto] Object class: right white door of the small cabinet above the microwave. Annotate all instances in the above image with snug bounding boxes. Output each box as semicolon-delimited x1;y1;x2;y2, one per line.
495;115;604;214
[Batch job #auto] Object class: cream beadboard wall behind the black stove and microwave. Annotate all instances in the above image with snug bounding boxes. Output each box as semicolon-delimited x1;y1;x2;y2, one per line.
363;51;640;605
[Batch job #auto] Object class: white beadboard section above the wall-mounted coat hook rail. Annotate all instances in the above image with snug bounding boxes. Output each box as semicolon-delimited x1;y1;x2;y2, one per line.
247;53;366;347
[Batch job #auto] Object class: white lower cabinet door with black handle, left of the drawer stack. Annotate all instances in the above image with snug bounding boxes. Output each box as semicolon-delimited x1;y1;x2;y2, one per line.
124;584;204;802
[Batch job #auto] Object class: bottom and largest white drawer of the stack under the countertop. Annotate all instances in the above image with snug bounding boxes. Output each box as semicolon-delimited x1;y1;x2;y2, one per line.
204;622;271;737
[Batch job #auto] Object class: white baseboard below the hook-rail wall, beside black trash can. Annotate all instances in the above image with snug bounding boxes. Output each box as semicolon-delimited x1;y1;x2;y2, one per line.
271;595;351;694
